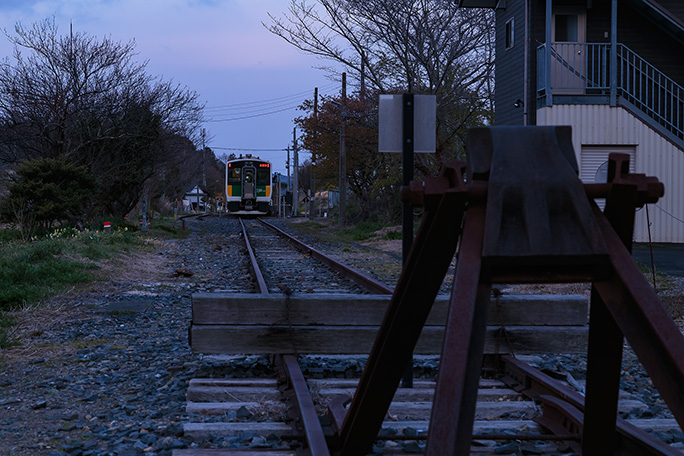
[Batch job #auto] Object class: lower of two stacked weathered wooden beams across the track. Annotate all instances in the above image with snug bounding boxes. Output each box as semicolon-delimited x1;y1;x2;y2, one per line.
190;325;588;355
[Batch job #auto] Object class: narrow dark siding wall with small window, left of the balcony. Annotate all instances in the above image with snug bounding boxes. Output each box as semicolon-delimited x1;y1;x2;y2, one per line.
494;1;534;125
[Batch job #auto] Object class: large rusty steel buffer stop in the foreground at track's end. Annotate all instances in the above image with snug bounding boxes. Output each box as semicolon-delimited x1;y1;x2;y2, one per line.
336;127;684;455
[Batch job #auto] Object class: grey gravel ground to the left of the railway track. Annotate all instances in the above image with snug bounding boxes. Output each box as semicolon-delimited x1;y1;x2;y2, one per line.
0;219;267;456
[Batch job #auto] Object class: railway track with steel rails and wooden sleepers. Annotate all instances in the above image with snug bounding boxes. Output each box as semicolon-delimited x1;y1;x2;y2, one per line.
178;216;684;456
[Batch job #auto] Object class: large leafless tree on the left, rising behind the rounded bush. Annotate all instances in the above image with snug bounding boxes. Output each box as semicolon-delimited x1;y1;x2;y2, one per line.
0;19;202;221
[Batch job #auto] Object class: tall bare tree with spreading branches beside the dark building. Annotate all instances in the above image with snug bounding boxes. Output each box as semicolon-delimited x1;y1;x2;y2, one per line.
266;0;494;174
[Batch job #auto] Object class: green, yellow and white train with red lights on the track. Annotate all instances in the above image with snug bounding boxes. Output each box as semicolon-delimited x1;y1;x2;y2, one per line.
226;154;273;215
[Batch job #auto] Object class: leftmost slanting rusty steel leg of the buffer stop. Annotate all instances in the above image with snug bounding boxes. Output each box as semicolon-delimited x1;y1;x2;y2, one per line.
340;163;467;456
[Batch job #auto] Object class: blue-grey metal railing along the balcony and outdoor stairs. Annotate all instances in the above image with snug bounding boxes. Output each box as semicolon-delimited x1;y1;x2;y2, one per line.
537;43;684;140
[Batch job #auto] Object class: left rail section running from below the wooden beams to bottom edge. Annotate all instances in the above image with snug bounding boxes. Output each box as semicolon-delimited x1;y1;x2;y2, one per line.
282;355;330;456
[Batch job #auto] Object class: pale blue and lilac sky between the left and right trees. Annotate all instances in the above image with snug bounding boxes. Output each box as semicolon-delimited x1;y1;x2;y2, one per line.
0;0;341;173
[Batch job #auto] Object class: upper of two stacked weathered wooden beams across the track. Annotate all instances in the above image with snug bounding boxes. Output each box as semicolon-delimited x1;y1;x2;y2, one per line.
192;293;588;326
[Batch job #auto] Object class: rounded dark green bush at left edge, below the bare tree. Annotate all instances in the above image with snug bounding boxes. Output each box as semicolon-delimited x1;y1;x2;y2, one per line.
0;158;95;234
